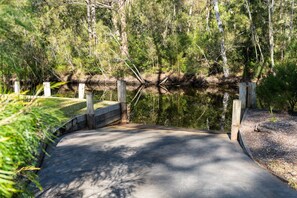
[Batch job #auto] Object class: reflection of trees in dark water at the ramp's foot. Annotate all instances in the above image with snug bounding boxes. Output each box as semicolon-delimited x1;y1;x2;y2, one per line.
128;87;235;131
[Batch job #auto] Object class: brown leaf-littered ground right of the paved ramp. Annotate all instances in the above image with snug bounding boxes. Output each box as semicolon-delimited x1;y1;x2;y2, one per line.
241;110;297;189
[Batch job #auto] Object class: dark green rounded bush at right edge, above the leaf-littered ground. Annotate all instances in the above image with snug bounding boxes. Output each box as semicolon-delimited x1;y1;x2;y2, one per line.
257;63;297;111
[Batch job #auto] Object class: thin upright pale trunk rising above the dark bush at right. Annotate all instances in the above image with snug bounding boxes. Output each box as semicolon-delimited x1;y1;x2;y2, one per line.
268;0;274;72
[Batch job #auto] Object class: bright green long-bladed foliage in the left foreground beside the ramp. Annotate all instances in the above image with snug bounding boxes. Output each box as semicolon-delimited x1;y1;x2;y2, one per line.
0;94;63;197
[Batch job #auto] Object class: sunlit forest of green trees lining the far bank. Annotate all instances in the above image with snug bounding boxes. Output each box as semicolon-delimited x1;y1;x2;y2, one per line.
0;0;297;83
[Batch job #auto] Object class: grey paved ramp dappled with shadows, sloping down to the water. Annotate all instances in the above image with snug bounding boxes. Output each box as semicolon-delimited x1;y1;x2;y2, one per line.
36;125;297;198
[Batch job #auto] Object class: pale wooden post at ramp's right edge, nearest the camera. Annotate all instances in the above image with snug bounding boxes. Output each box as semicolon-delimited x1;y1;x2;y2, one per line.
231;100;241;141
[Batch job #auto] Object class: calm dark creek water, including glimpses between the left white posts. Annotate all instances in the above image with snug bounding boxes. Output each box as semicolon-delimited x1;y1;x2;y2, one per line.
53;85;237;131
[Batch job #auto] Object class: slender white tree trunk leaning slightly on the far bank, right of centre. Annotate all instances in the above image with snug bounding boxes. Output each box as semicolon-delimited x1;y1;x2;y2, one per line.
213;0;229;78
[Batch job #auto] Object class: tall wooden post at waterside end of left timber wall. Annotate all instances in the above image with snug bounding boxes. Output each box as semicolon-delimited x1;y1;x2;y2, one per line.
117;80;129;123
